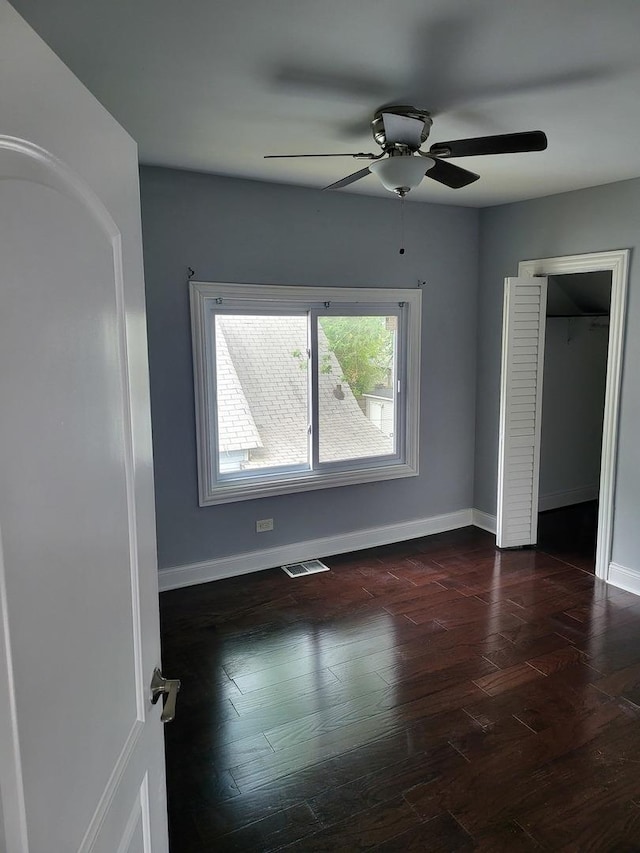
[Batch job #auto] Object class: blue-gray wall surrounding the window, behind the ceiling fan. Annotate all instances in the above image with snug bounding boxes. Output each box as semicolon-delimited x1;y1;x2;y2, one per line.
141;168;479;568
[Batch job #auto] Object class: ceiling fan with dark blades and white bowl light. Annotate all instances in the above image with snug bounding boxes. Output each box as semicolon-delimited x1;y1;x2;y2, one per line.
265;105;547;198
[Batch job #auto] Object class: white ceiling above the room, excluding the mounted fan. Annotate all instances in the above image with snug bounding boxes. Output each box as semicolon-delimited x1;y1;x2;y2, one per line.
12;0;640;207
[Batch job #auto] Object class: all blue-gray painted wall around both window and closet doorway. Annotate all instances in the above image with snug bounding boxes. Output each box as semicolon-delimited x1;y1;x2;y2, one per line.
141;167;640;568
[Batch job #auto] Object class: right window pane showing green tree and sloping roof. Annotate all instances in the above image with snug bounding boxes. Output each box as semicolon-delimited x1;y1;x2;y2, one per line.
318;315;398;462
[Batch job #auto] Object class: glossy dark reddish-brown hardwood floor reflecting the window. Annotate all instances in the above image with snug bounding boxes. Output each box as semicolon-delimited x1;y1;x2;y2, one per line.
161;528;640;853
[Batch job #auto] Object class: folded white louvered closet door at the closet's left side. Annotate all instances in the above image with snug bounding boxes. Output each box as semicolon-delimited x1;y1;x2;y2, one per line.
496;277;547;548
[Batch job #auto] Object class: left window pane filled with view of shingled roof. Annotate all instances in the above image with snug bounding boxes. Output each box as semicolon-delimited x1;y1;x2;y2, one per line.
215;314;309;475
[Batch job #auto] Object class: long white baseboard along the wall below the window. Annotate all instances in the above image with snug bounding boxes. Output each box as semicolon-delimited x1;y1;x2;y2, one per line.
159;509;474;592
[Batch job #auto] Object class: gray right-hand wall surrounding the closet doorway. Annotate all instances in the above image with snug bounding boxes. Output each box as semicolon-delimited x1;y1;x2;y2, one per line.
475;179;640;570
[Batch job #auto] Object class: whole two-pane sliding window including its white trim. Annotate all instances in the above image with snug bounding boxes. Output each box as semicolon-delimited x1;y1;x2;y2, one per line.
191;282;421;506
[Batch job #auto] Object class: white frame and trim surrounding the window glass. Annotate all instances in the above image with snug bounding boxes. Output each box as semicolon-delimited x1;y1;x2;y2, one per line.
189;281;422;506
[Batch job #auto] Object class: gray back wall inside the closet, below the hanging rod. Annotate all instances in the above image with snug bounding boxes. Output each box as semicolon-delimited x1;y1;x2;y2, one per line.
540;317;609;509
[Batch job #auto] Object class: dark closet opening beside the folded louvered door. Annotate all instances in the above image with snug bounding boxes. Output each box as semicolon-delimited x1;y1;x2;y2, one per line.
537;270;612;572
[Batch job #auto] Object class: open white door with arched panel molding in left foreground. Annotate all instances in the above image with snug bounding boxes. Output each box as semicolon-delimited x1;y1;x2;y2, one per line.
0;0;167;853
